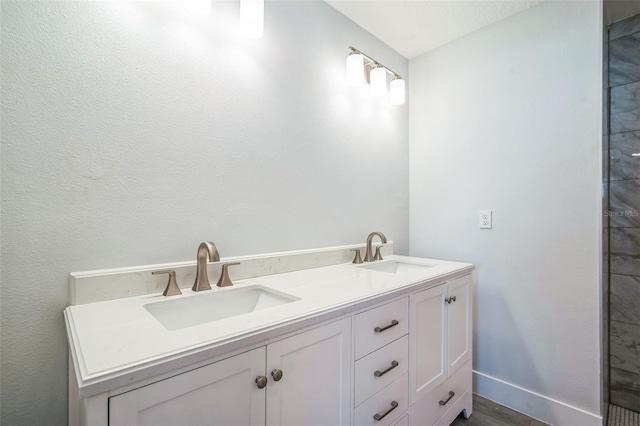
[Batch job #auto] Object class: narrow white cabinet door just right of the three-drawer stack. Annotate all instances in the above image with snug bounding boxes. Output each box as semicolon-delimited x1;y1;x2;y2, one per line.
409;284;447;404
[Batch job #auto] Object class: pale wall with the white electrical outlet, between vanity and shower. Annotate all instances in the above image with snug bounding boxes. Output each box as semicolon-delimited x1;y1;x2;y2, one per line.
409;1;602;425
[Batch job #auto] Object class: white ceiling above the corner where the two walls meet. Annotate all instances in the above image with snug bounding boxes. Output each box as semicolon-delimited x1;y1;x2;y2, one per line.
325;0;543;59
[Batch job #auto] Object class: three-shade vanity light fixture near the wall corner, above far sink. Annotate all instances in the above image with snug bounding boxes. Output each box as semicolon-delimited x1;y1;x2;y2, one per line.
347;46;406;105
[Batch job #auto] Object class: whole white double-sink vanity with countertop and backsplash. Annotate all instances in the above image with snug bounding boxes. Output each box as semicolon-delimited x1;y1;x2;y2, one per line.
65;238;473;426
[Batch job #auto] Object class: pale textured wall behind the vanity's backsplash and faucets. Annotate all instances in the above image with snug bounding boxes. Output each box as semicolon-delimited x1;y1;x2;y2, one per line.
1;1;409;425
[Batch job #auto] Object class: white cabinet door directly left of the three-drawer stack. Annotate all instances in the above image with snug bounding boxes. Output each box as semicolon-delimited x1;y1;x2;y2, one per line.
267;318;351;426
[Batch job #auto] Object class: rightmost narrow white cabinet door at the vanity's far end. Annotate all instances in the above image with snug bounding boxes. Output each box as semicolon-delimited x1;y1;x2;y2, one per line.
447;275;471;376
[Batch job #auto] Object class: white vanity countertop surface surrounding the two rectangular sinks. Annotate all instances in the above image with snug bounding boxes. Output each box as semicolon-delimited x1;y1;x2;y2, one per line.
65;256;473;396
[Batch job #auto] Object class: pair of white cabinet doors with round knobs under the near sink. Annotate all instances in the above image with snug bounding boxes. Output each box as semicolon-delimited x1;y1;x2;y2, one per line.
109;318;351;426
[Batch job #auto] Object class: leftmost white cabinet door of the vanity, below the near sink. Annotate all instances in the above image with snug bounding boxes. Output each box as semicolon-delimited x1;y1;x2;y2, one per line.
109;347;266;426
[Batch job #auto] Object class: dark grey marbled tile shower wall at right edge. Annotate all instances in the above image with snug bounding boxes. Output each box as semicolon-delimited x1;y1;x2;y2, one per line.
603;15;640;411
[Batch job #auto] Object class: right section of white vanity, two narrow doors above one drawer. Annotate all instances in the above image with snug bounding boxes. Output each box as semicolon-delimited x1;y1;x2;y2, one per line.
409;275;472;426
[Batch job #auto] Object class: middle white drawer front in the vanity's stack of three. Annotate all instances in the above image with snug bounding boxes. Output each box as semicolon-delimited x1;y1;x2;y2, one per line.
355;335;409;407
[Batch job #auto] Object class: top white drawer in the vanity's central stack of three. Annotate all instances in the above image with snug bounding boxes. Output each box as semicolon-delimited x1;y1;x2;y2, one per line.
355;298;409;359
